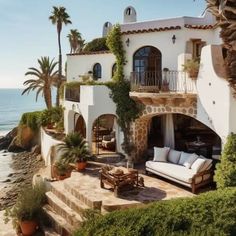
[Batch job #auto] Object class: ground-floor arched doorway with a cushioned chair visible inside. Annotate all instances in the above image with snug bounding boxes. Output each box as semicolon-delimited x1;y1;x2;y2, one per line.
92;114;117;155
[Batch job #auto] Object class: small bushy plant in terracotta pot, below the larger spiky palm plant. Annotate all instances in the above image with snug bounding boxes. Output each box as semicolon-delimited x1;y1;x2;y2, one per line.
54;159;71;180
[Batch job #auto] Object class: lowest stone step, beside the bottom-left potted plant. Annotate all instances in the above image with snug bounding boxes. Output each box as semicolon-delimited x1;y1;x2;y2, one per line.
43;204;75;236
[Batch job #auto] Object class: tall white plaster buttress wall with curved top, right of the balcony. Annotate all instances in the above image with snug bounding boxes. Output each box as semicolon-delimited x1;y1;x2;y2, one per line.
197;45;236;143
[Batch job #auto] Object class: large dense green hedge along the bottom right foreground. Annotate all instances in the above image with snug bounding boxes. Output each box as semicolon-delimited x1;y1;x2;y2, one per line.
75;188;236;236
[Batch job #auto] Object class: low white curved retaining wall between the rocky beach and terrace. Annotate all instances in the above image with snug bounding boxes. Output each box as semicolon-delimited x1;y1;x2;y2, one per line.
41;128;62;166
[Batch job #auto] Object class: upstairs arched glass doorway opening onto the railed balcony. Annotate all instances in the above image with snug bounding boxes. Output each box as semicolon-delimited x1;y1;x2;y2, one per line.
133;46;162;87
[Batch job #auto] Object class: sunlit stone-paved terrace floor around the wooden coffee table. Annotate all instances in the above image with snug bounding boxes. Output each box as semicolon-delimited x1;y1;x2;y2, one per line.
59;162;193;211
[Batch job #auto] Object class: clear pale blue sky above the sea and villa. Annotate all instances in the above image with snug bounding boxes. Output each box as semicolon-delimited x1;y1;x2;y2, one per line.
0;0;205;88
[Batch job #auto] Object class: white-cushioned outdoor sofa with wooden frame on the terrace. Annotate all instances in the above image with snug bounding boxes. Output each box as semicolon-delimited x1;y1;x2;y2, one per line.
146;147;213;193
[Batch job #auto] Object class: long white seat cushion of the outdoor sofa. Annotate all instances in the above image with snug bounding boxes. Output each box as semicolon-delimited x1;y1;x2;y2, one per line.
146;161;195;183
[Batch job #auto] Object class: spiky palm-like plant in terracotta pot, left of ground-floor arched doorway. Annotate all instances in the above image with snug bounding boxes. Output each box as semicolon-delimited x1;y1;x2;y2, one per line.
58;132;90;171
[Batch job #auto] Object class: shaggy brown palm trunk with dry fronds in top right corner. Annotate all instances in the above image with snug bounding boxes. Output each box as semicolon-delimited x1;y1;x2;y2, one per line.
206;0;236;94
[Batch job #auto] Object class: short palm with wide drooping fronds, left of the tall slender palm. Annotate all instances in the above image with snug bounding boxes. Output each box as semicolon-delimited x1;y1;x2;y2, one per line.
22;57;58;109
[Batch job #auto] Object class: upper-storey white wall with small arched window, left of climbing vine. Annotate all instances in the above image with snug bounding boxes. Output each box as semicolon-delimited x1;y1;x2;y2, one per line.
67;53;115;82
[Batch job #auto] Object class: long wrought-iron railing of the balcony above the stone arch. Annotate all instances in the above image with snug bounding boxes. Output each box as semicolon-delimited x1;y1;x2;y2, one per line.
131;71;196;93
